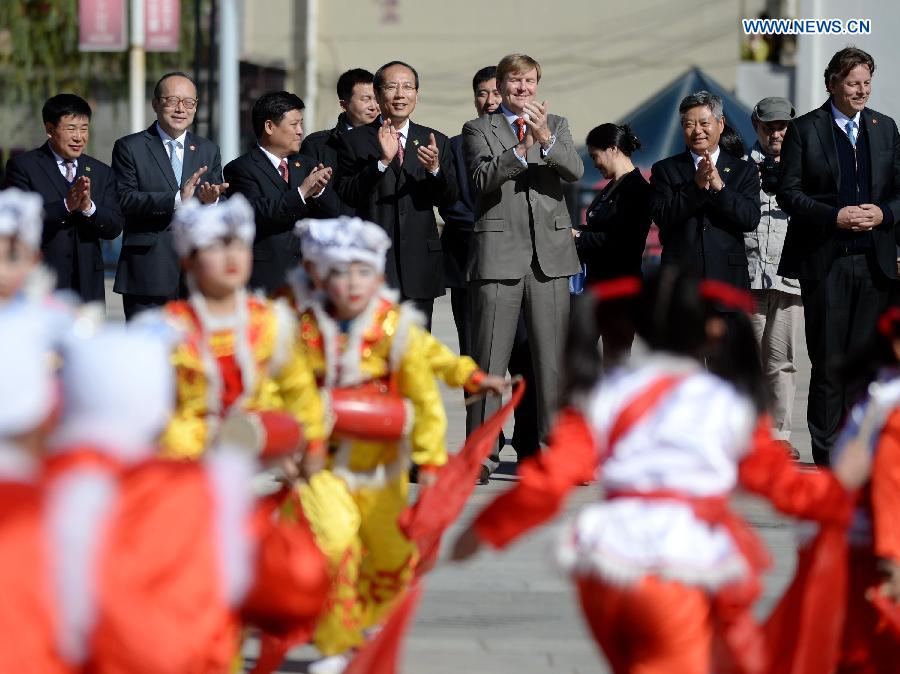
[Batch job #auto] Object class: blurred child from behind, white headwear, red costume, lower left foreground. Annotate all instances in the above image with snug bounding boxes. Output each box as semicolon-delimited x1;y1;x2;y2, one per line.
39;319;330;674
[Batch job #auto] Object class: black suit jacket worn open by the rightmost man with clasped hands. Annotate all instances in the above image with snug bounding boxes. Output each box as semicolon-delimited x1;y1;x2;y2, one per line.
777;101;900;280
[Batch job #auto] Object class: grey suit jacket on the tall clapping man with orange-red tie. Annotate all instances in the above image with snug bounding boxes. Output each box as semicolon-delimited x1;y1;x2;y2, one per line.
463;112;584;281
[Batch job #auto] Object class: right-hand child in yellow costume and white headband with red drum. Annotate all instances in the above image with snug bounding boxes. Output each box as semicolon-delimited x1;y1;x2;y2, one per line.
290;218;458;674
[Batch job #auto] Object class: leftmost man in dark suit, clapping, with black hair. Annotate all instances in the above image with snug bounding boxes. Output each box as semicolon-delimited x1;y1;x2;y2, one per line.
6;94;122;302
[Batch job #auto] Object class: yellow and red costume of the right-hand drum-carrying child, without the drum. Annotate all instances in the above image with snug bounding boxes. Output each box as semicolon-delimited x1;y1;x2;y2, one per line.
299;293;448;656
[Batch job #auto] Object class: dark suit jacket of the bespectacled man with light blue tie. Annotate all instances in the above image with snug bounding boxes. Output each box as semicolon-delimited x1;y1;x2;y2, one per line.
112;122;222;297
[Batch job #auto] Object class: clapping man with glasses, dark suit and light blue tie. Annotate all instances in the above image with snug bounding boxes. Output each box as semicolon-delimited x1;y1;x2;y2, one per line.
112;72;228;319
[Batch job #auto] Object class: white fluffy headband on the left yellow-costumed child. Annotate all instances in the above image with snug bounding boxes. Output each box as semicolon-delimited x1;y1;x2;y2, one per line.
172;194;256;257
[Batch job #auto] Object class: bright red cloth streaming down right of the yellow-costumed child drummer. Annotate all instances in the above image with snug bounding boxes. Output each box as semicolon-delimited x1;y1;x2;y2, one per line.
399;381;525;575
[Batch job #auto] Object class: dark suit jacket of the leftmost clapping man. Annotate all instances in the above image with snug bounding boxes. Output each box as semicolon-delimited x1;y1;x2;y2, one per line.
6;143;122;302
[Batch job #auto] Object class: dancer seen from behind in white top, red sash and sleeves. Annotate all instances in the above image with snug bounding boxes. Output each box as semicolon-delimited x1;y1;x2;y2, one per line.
454;268;849;674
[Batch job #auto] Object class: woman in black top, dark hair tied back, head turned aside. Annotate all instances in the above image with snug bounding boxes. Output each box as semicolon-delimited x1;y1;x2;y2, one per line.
573;124;651;366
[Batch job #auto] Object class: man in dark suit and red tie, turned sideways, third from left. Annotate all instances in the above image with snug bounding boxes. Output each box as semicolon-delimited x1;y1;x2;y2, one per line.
225;91;336;294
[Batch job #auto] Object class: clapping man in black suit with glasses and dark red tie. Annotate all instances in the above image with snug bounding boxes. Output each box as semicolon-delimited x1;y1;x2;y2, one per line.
337;61;459;329
